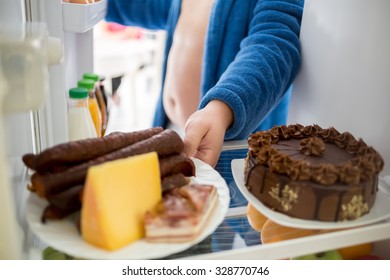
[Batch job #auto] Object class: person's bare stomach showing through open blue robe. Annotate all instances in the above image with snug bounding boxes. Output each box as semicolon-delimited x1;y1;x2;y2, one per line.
163;0;213;129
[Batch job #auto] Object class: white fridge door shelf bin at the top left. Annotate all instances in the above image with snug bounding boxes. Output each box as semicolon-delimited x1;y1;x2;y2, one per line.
62;0;107;33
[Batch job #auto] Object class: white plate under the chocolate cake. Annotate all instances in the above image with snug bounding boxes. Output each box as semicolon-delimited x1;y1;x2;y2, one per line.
232;159;390;229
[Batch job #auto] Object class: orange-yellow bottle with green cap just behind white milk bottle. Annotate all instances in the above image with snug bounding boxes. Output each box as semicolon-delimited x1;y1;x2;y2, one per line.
77;79;102;137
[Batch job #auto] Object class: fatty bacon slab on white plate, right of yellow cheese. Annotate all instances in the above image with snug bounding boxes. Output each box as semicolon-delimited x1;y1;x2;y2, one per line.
144;184;218;243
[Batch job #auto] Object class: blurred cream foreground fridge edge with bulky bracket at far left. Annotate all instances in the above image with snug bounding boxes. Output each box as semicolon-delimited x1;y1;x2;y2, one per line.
0;22;62;259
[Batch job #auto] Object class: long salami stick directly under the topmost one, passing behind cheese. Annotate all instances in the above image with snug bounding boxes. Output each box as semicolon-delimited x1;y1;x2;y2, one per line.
30;129;184;198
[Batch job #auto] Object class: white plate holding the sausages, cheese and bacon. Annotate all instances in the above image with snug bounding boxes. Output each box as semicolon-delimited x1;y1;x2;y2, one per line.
26;158;230;259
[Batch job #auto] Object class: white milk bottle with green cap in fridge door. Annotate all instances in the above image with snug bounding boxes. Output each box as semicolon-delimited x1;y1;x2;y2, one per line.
68;88;97;141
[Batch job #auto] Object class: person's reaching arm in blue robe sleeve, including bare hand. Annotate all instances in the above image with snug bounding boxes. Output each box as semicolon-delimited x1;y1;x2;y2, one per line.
184;0;303;166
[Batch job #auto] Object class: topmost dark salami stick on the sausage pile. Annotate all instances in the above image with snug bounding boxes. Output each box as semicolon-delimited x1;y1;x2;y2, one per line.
22;127;163;173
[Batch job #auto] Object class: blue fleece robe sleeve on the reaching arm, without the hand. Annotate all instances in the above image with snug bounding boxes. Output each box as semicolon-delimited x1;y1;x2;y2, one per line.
200;0;303;140
